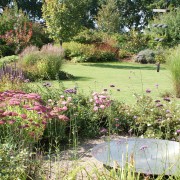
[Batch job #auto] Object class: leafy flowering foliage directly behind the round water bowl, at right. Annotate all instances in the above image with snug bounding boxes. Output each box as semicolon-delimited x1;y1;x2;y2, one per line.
129;94;180;140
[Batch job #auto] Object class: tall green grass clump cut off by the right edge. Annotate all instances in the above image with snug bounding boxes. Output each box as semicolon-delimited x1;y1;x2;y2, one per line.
168;45;180;98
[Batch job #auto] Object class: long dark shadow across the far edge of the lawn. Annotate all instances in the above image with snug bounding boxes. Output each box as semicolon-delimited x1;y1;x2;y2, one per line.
83;63;165;71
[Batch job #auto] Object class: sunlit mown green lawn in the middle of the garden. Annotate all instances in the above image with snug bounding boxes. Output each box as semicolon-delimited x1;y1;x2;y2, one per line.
56;63;173;103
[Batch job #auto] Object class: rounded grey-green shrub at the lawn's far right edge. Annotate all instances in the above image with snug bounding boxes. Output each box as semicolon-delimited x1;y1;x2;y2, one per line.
135;49;155;64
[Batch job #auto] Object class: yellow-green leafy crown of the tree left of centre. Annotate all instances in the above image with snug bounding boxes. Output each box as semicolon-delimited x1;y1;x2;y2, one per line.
42;0;89;41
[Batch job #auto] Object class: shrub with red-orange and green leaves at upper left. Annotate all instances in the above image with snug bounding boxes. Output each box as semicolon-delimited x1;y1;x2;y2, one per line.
0;4;32;55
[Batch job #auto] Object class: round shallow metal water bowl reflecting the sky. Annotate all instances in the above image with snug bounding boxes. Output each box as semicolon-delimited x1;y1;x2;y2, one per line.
92;138;180;175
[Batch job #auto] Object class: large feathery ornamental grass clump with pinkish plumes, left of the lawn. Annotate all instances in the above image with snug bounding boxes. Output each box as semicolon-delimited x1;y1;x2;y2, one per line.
19;45;63;80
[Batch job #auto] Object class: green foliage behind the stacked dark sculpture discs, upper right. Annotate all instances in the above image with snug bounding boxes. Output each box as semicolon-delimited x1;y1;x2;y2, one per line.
146;8;180;47
